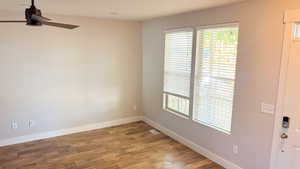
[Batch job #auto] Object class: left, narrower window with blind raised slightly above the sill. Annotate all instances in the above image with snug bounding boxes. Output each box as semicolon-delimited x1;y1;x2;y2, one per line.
164;30;193;117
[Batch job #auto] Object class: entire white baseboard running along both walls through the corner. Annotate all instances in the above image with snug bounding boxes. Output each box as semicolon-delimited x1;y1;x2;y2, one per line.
0;116;242;169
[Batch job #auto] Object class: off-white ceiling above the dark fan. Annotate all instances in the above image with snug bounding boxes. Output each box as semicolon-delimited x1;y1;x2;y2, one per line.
0;0;241;20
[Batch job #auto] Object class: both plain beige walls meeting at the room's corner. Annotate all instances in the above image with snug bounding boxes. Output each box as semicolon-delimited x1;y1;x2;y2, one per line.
0;0;300;169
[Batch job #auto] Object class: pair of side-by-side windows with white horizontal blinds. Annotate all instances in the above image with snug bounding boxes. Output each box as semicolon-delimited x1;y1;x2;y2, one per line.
163;24;239;133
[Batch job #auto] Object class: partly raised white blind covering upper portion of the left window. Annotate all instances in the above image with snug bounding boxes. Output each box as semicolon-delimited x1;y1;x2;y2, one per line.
164;31;193;97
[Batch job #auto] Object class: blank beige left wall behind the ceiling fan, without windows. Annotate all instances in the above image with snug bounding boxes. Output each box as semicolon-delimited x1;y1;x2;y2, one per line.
0;11;142;140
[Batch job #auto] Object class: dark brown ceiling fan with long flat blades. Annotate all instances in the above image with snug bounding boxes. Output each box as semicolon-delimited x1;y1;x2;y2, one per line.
0;0;79;29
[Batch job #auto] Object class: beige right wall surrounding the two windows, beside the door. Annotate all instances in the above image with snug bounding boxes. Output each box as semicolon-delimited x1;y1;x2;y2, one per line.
143;0;300;169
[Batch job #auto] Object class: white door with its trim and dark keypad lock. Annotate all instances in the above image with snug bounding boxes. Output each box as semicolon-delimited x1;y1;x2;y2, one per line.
272;10;300;169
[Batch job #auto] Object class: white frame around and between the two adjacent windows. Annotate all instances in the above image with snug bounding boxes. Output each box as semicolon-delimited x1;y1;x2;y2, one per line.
162;21;240;135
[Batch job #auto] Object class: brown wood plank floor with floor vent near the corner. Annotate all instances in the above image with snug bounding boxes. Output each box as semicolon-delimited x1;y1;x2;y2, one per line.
0;122;224;169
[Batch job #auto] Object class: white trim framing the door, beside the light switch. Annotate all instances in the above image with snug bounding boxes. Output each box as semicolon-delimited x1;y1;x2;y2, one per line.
270;10;300;169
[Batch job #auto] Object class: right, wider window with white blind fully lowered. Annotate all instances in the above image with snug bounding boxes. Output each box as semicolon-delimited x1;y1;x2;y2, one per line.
193;25;239;132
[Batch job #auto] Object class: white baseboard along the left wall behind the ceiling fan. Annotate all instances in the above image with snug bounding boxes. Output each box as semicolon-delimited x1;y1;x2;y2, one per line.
0;116;143;147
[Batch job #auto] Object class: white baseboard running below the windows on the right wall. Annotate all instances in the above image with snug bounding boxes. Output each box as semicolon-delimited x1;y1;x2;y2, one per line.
143;117;242;169
